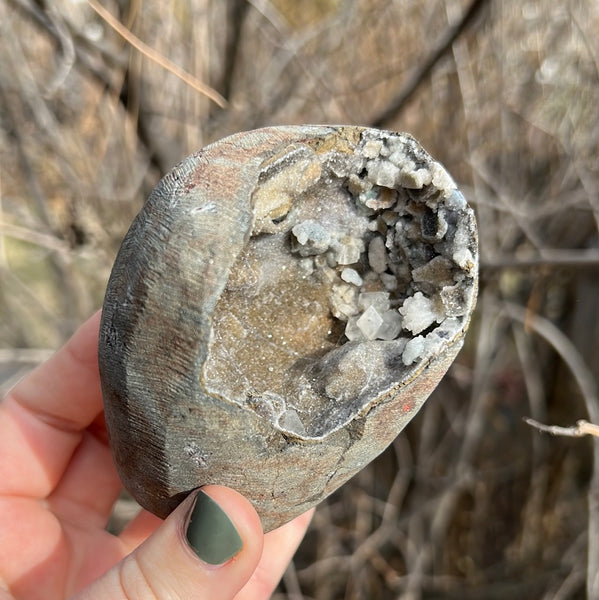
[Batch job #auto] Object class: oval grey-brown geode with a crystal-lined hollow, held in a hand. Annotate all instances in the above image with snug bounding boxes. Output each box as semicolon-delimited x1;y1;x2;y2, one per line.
99;126;478;530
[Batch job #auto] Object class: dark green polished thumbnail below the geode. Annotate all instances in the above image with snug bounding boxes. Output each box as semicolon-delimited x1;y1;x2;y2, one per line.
186;490;243;565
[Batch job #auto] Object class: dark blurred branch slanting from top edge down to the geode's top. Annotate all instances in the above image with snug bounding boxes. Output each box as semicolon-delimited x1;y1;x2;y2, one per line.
371;0;489;127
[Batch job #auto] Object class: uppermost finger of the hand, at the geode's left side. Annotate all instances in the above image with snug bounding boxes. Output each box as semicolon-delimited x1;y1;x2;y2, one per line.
0;312;102;498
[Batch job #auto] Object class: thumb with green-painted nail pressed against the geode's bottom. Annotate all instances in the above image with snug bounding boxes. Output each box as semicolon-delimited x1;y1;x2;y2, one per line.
75;486;264;600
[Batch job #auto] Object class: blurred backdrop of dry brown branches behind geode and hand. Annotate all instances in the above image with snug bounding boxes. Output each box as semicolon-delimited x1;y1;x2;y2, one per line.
0;0;599;600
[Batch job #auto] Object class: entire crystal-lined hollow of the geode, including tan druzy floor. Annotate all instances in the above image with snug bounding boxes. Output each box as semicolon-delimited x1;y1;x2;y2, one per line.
202;135;474;438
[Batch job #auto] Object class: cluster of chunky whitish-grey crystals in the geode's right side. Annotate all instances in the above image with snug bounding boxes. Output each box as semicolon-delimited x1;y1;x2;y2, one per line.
291;135;474;365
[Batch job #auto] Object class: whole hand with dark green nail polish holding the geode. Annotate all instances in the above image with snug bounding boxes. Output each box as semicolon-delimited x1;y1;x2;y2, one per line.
0;313;311;600
